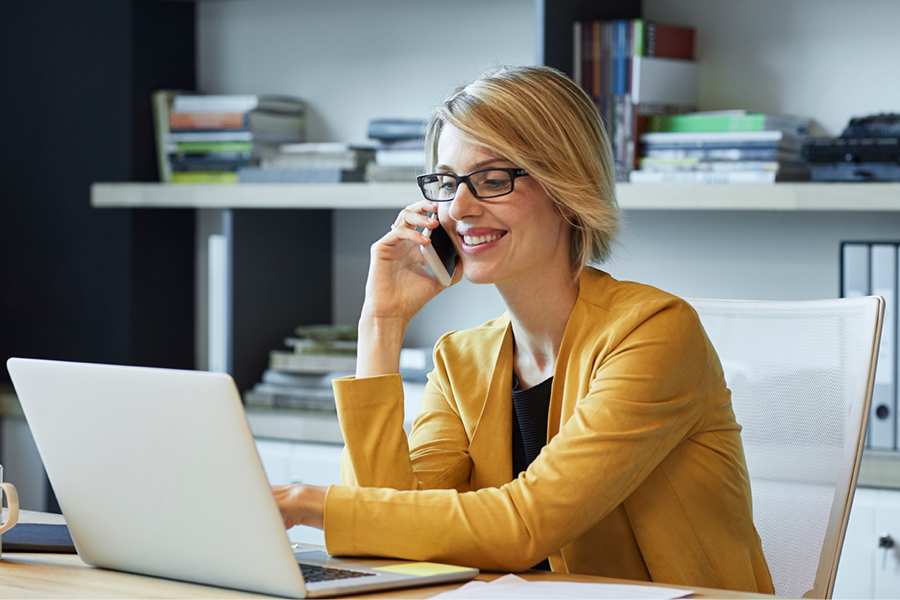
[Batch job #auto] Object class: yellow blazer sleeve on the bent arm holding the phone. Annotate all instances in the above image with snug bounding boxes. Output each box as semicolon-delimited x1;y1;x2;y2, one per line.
334;346;472;491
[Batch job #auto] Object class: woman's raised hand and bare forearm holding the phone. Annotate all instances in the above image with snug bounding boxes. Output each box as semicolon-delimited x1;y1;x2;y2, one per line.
356;200;462;377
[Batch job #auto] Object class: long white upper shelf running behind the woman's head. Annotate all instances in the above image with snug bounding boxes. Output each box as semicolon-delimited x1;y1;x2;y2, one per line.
91;183;900;211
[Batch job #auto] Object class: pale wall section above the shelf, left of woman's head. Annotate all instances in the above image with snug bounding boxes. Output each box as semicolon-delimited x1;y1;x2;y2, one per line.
197;0;535;143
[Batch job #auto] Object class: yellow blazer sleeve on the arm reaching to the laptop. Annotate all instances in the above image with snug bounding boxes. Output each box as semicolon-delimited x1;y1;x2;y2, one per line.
325;302;708;571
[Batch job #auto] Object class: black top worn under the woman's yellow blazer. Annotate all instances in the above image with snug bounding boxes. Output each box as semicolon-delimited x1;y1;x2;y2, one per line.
512;373;553;571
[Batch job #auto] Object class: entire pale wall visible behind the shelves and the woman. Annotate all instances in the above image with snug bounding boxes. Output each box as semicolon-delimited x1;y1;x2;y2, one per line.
198;0;900;345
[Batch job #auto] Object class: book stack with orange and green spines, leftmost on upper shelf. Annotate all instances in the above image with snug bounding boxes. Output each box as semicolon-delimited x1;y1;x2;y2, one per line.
153;90;306;183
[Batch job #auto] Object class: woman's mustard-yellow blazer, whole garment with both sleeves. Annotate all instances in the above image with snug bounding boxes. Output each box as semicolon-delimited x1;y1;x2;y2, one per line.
325;268;773;593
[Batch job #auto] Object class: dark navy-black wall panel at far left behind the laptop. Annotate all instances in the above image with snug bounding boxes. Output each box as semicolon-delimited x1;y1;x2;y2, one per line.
0;0;195;381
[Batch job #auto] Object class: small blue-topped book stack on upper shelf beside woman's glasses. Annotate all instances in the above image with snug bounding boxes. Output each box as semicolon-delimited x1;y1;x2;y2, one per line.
366;119;425;182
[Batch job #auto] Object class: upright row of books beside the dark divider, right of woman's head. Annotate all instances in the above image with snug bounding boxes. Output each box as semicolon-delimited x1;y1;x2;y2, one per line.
573;19;699;180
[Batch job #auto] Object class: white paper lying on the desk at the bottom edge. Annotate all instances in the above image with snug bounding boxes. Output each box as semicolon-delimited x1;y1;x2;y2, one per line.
433;575;692;600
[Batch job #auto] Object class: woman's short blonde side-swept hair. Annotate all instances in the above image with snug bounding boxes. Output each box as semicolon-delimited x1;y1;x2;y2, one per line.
425;66;619;270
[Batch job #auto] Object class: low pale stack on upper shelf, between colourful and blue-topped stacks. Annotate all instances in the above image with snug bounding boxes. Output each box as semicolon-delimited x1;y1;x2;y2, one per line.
238;143;375;183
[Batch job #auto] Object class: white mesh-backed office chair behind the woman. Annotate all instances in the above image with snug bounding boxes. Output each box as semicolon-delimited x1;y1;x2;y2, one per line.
688;296;884;598
